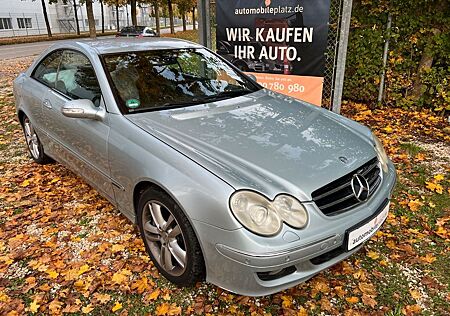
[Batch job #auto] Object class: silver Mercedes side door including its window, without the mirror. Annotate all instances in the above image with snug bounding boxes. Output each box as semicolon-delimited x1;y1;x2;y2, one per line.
42;50;114;201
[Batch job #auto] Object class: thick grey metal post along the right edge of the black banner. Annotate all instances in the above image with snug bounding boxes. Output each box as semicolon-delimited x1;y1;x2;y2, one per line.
332;0;352;113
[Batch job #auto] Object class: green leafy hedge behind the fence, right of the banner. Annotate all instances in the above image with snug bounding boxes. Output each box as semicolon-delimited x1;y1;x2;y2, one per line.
344;0;450;113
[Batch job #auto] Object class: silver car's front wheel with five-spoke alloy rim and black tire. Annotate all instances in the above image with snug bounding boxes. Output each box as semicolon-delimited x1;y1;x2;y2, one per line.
137;188;206;286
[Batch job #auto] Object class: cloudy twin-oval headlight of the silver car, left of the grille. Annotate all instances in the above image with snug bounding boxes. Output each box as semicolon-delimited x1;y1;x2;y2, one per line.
230;191;308;236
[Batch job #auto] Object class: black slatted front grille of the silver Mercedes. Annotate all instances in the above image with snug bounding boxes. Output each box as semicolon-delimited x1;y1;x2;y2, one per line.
311;158;381;216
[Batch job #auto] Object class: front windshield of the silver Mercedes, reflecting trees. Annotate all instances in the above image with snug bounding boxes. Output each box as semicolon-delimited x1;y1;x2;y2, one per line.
102;49;260;113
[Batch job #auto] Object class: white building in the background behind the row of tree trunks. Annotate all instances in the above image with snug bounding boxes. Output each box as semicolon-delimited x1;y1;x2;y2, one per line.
0;0;154;37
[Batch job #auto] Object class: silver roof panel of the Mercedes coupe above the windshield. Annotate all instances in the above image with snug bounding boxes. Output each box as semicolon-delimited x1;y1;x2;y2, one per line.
52;37;203;55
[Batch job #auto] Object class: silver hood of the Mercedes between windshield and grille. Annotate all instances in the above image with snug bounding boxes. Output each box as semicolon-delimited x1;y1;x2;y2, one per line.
126;90;376;201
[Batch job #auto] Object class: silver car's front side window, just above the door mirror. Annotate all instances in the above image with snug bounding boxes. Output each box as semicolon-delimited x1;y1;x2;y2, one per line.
55;50;101;107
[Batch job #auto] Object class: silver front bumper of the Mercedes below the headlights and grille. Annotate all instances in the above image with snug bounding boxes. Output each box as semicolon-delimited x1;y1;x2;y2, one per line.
194;164;396;296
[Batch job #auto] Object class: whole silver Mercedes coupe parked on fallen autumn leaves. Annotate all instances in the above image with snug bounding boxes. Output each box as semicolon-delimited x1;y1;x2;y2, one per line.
14;38;396;296
